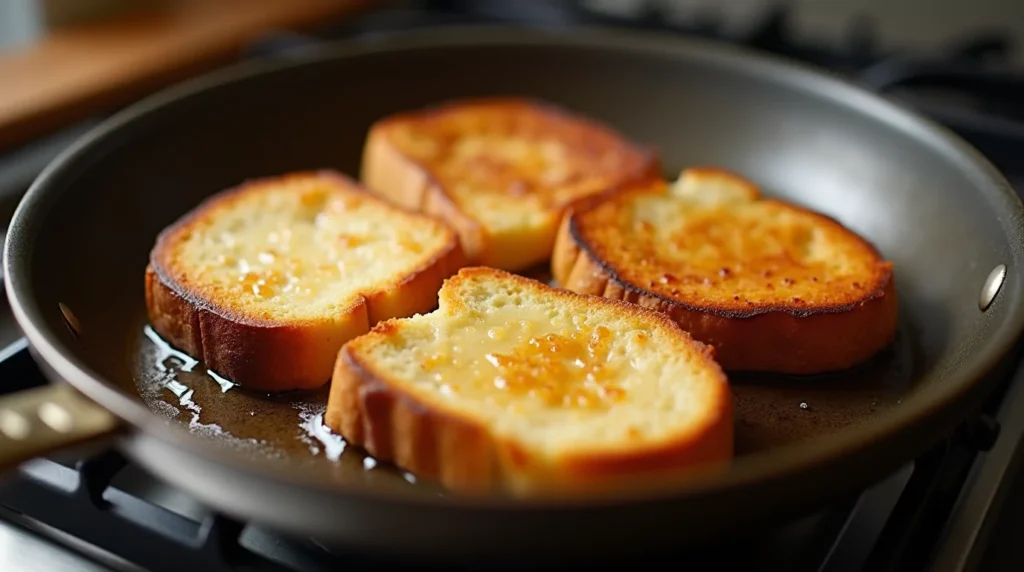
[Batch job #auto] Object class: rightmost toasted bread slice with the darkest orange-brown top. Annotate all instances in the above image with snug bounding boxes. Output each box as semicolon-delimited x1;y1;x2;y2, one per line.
552;169;897;373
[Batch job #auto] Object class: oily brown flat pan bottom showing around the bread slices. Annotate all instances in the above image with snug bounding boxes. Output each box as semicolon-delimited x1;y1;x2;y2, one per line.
129;268;914;494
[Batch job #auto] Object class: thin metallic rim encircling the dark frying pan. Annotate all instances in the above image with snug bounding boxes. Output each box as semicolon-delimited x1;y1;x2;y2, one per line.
3;25;1024;511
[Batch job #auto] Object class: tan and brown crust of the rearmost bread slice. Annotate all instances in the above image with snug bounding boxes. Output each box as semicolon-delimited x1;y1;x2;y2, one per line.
360;97;660;270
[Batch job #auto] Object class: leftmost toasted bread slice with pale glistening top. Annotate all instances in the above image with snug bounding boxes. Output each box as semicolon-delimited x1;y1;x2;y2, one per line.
145;172;464;391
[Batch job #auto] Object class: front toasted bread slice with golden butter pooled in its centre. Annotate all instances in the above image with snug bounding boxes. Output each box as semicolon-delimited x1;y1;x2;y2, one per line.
326;268;732;496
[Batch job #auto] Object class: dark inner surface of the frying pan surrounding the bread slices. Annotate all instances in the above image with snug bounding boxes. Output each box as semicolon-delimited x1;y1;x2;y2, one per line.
18;36;1016;495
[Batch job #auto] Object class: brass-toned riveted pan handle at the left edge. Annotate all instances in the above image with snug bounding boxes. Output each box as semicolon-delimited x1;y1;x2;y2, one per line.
0;383;120;472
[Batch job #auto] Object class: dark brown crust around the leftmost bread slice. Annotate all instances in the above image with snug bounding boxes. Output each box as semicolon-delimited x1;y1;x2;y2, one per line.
145;171;465;392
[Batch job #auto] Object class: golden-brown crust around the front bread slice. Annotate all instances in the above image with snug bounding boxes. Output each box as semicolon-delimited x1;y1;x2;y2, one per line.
325;268;733;497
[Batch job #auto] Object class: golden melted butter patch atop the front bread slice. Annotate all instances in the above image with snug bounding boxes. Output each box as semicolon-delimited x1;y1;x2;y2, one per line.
421;312;626;409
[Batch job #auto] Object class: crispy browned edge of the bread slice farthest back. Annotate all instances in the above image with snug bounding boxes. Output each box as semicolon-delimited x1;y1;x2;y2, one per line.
359;97;660;270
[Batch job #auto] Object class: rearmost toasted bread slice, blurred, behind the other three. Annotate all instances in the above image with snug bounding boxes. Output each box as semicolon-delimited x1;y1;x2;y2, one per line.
361;98;658;270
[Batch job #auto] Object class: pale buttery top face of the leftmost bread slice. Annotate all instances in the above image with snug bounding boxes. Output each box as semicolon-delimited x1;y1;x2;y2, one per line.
180;177;444;312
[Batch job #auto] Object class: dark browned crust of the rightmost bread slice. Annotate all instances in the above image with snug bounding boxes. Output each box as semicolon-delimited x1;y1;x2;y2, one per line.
551;169;899;375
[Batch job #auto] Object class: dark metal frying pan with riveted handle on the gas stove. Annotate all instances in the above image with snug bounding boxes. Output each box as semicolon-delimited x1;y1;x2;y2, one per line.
0;27;1024;558
